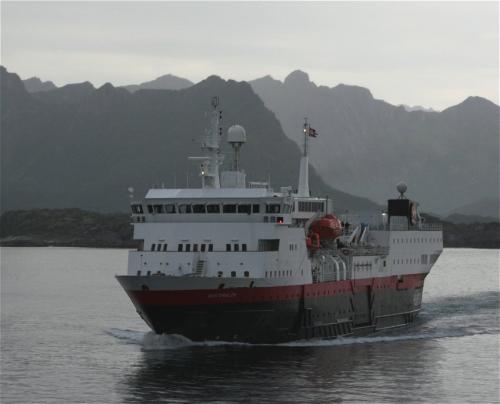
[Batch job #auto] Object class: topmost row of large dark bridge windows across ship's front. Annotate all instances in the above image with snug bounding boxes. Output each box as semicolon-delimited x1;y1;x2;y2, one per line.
131;203;291;215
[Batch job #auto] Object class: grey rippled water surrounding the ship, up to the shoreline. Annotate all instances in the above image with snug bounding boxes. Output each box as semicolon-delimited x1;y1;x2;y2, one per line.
0;248;500;403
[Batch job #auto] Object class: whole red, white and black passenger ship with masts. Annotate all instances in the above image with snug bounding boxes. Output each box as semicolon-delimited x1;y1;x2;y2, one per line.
116;97;443;343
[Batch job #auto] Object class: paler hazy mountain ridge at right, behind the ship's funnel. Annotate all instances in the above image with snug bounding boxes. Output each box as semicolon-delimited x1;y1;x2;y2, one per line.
250;71;500;214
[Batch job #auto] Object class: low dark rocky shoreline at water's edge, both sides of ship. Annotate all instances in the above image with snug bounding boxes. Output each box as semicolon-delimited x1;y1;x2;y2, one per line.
0;209;500;249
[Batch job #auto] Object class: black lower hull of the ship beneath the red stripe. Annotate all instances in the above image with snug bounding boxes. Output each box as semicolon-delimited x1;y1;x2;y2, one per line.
121;274;425;343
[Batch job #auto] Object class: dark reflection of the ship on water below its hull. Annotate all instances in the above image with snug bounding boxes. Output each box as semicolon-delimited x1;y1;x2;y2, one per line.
119;341;440;403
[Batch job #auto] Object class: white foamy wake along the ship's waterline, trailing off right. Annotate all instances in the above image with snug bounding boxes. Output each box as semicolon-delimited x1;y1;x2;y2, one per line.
105;292;500;351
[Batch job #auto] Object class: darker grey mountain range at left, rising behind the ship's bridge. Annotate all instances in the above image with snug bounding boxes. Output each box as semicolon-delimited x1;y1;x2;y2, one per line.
0;67;379;215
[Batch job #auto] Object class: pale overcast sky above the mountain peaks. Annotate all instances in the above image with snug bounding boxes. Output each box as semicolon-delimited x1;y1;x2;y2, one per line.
1;2;499;109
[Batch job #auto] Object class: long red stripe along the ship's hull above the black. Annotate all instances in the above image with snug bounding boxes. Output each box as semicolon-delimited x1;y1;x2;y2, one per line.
127;274;426;306
